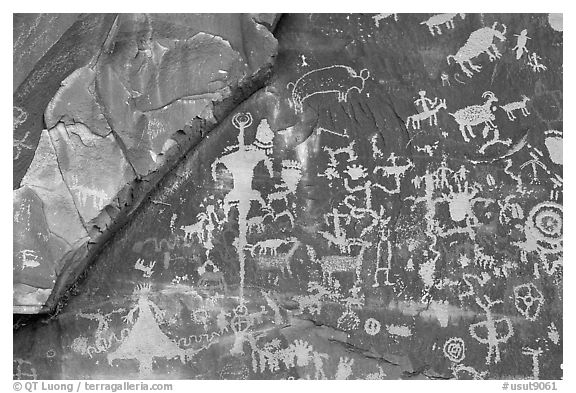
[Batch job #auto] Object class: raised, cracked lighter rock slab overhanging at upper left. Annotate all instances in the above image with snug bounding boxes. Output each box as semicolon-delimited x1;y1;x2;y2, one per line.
14;14;276;313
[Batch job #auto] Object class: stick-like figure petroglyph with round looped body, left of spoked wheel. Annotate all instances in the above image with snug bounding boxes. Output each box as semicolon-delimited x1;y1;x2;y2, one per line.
469;296;514;365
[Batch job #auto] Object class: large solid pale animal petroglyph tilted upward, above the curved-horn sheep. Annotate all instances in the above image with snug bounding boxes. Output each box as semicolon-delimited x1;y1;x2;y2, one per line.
446;22;506;78
